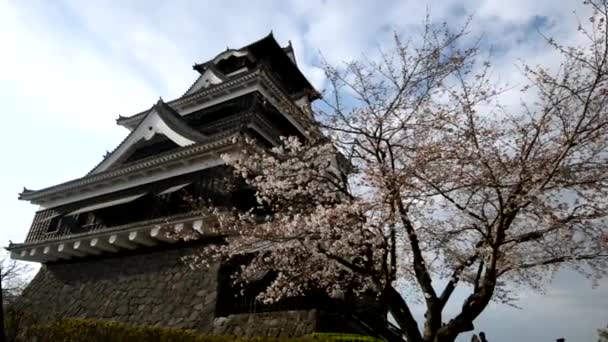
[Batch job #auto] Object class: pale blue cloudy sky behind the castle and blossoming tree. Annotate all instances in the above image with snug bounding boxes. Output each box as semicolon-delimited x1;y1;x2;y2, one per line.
0;0;608;342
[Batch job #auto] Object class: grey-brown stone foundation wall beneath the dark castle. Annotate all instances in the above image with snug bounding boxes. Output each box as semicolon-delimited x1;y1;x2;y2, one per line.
16;248;316;337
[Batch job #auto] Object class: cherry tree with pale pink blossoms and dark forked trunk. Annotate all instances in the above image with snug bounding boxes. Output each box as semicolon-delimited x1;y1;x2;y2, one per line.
183;0;608;342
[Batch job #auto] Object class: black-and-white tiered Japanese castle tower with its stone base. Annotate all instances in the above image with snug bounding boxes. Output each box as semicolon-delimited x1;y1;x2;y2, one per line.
7;34;400;336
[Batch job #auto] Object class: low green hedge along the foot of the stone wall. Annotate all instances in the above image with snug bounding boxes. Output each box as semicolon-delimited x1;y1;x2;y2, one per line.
23;319;381;342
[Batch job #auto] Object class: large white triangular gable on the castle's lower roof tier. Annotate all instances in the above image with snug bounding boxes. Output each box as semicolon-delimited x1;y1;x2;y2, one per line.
89;99;208;174
